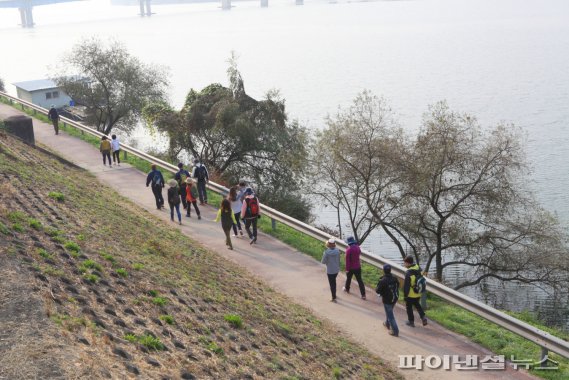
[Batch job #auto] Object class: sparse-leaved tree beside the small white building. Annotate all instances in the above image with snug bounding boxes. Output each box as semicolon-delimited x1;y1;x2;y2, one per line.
53;38;168;134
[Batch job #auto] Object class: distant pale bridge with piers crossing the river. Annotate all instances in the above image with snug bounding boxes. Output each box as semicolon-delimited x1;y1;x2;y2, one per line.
0;0;304;28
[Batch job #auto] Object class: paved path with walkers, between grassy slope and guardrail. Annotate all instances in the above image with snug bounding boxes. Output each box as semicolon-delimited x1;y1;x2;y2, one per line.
0;104;534;380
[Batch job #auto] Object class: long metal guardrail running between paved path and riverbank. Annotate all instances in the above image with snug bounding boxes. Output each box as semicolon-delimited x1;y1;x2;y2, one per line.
0;92;569;359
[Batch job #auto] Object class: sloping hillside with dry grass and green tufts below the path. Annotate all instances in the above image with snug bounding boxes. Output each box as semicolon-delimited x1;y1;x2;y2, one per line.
0;130;399;379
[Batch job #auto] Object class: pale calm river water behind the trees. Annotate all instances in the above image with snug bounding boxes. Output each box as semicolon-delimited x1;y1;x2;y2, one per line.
0;0;569;323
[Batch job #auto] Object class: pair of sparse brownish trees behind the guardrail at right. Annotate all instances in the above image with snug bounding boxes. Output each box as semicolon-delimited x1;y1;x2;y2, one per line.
313;92;569;289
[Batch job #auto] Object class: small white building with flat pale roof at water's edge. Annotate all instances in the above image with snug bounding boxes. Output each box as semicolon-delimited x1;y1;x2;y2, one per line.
12;79;71;109
